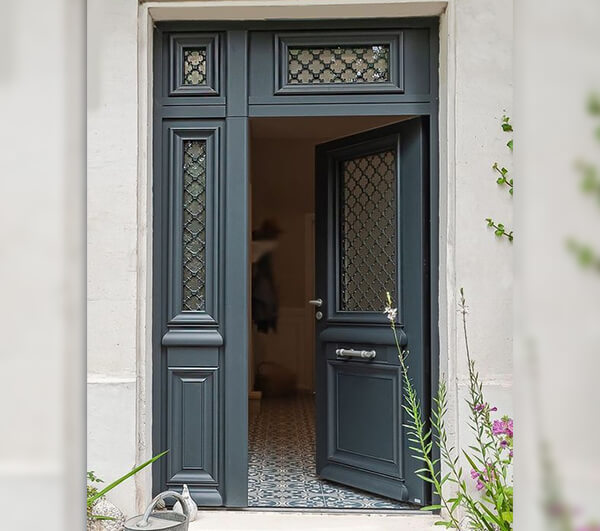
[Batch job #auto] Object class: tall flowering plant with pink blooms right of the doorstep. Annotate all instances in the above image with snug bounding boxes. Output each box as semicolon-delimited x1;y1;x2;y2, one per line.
384;289;513;531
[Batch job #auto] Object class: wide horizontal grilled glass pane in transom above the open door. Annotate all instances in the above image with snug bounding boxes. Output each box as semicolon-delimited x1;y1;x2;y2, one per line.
287;44;390;85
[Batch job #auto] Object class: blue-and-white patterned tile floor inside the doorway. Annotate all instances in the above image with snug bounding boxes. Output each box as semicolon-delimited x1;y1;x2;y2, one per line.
248;394;412;511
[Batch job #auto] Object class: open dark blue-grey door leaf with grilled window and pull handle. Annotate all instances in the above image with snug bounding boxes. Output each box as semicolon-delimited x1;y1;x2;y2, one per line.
313;118;429;504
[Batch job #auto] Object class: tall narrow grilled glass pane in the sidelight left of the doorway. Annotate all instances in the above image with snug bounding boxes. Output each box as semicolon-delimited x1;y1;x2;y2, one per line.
182;140;206;312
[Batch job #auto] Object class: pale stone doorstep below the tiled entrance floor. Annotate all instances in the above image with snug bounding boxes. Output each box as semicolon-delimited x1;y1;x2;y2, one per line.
189;510;439;531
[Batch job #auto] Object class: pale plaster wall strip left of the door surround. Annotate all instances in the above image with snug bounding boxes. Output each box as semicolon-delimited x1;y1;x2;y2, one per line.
87;0;138;514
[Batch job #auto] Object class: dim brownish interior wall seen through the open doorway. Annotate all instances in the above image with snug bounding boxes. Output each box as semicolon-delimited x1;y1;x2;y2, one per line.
249;116;395;391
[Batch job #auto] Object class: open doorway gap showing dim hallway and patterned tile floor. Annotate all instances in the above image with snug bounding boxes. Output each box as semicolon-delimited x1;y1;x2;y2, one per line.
248;116;410;510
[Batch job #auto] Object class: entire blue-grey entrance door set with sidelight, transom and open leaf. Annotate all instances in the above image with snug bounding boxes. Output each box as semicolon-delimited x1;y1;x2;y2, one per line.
151;18;439;507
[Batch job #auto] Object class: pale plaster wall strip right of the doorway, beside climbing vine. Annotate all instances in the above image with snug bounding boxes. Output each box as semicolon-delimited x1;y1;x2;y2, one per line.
450;0;518;428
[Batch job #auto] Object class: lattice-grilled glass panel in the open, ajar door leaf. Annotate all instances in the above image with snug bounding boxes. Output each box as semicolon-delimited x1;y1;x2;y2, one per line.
339;150;398;312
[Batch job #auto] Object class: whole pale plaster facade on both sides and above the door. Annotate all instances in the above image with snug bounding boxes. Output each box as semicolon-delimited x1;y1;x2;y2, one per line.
88;0;518;514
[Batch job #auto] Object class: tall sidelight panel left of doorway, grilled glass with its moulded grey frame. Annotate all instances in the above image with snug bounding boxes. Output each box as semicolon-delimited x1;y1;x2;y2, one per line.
167;122;222;325
